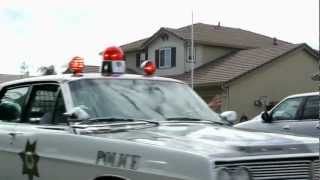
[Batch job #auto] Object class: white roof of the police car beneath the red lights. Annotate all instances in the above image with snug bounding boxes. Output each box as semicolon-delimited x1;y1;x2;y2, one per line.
1;73;185;87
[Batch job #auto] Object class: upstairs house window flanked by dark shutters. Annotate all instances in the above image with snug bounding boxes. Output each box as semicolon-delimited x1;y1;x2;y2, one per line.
155;47;176;69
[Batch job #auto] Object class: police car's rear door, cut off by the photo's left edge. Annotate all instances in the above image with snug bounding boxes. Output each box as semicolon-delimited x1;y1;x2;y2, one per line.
0;86;29;180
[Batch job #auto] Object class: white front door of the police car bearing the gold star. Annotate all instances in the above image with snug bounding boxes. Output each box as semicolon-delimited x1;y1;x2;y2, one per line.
11;84;102;180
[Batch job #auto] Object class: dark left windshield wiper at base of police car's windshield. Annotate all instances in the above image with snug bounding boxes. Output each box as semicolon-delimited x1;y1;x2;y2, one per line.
77;117;160;126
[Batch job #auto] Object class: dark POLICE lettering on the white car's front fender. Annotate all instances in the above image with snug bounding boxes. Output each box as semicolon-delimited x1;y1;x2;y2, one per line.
96;151;141;170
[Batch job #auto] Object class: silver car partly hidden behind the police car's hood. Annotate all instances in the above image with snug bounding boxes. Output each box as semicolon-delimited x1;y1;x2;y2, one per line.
235;92;320;137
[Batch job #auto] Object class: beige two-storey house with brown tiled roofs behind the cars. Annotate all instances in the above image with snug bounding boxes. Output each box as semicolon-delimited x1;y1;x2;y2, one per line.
121;23;318;118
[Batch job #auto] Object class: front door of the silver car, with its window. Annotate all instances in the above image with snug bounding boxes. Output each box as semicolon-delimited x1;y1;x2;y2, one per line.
265;97;306;134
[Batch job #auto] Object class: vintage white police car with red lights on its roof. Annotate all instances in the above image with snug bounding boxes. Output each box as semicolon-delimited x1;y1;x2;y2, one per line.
0;48;320;180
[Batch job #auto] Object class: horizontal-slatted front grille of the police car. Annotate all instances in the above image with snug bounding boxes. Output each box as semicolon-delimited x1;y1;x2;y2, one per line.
216;158;320;180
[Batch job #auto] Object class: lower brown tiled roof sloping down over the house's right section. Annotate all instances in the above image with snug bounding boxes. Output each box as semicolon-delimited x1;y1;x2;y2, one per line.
171;44;316;85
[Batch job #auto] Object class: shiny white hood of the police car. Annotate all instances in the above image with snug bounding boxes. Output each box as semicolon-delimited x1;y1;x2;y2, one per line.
92;123;319;157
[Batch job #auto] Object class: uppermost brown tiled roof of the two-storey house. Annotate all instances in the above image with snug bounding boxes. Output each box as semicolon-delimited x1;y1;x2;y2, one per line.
121;23;290;52
